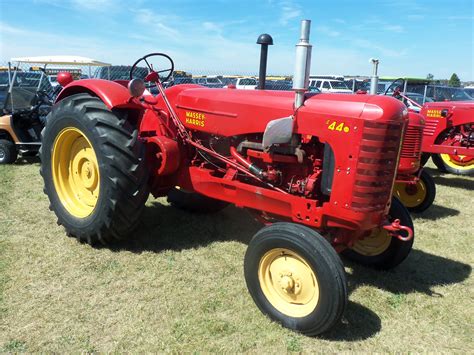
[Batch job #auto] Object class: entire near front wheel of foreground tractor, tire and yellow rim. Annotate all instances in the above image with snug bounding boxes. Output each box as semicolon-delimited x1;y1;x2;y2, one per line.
244;223;347;335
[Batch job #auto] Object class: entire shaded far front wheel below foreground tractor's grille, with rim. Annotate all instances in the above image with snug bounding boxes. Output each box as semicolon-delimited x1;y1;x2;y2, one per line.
342;197;415;270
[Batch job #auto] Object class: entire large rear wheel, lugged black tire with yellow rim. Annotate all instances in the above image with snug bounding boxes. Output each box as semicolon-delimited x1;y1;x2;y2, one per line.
40;94;148;244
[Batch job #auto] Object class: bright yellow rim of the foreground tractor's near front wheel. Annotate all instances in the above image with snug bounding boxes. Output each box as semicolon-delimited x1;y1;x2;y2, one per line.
258;248;319;318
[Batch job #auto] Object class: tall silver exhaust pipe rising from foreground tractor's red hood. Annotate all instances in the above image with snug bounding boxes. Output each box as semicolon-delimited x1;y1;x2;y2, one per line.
293;20;312;109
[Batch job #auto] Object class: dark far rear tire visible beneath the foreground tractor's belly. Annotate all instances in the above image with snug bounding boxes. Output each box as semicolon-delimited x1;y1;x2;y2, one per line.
168;187;229;213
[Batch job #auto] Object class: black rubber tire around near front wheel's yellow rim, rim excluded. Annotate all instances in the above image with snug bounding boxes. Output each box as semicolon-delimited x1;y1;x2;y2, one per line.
244;222;348;336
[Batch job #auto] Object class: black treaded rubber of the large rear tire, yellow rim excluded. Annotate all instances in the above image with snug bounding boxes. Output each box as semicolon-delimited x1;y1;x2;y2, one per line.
40;94;149;245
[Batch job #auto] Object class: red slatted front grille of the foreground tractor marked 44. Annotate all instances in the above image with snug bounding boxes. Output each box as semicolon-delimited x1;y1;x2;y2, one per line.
351;122;403;212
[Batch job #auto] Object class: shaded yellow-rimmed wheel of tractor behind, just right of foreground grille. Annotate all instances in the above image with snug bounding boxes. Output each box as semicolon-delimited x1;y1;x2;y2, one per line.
393;170;436;213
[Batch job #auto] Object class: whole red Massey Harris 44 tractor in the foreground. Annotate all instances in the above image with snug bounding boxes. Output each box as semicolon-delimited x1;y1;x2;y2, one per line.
41;21;414;335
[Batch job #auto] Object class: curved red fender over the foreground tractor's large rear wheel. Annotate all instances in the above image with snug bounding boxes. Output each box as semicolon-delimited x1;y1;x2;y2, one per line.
55;79;143;110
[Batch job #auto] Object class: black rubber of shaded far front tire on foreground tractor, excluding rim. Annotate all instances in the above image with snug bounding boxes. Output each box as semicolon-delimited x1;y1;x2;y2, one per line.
341;196;415;270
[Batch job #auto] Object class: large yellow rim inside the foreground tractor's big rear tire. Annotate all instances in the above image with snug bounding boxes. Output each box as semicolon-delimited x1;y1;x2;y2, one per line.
51;127;100;218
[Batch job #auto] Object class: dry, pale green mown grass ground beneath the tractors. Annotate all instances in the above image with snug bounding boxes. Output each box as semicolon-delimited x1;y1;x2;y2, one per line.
0;161;474;353
